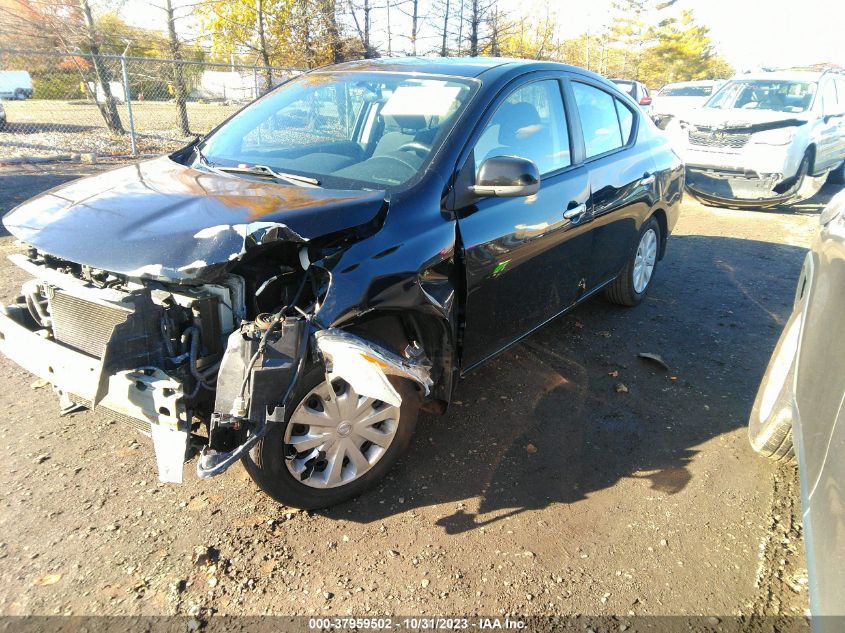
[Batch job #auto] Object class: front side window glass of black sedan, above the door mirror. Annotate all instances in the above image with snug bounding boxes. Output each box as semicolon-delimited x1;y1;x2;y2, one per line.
473;79;571;175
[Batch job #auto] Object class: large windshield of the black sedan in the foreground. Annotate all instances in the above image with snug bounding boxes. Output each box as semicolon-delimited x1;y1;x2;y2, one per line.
200;72;475;189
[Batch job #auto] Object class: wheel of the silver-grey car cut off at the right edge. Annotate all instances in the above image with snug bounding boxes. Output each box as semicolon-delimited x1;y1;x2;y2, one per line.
748;313;800;463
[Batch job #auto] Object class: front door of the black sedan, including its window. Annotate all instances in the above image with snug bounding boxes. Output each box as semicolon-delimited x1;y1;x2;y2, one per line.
456;76;591;371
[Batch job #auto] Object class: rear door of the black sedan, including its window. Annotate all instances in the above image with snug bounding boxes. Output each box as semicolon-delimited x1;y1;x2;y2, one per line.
570;79;655;289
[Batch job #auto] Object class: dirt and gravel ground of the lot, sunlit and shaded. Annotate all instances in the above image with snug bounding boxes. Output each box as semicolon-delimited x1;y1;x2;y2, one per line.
0;165;835;630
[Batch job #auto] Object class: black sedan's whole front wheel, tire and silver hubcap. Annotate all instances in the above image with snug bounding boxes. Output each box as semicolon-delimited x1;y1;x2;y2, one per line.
244;365;420;509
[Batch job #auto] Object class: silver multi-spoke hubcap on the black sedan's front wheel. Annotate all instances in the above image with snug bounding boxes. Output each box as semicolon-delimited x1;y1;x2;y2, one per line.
284;378;399;488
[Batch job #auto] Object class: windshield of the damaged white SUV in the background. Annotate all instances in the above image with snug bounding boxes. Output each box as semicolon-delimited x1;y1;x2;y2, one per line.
704;79;816;112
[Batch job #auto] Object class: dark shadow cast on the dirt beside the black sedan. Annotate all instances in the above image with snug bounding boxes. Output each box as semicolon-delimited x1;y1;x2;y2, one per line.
324;236;806;534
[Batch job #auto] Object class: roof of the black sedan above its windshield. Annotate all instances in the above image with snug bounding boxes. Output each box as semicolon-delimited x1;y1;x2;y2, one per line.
319;57;607;82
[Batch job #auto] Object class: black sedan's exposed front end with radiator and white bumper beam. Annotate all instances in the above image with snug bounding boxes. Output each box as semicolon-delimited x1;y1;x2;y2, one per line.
0;251;252;482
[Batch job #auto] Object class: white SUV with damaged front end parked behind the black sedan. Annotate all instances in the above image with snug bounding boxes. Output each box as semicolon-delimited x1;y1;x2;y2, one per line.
666;71;845;207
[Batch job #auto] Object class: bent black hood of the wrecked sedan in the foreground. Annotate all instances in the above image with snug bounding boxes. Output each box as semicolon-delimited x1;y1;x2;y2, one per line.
3;157;386;283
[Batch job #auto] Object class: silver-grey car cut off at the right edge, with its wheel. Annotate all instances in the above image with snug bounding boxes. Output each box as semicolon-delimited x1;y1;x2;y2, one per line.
748;191;845;616
